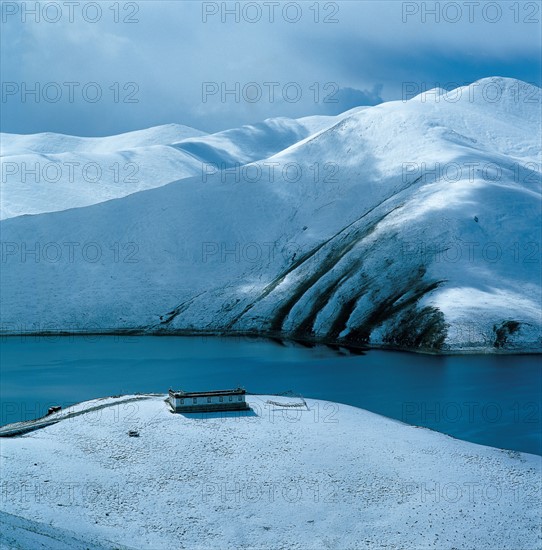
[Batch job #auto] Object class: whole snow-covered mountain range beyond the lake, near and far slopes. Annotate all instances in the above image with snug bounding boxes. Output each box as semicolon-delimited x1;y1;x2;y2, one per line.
1;78;542;352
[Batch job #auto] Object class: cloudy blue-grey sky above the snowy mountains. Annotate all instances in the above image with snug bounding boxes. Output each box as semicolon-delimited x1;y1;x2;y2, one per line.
0;0;542;136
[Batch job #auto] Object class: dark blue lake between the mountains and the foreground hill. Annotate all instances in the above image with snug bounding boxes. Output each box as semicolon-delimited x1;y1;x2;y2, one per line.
0;336;542;454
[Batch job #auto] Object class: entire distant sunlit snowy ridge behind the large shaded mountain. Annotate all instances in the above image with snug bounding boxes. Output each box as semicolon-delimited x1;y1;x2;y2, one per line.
0;117;340;219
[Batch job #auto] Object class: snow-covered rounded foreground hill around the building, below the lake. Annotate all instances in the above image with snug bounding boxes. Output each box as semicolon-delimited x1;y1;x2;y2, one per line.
0;395;542;550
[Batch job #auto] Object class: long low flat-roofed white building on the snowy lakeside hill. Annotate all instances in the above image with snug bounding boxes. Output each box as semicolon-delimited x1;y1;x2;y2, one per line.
168;388;249;412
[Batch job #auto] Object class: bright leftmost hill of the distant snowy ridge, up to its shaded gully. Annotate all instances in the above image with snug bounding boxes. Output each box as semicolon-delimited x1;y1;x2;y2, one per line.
0;124;207;219
